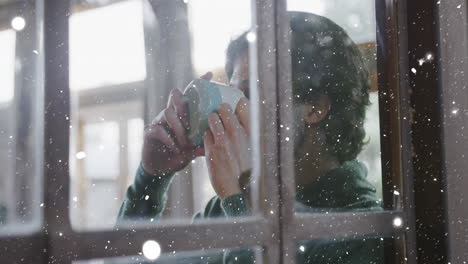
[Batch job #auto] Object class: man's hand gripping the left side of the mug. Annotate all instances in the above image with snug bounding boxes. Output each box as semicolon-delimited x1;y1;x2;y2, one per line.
142;89;205;176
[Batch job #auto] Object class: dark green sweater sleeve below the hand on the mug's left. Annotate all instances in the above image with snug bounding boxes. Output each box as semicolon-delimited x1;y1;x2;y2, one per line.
118;165;174;222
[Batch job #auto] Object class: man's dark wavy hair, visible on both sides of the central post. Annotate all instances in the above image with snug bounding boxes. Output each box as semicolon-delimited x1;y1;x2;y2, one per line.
225;12;370;163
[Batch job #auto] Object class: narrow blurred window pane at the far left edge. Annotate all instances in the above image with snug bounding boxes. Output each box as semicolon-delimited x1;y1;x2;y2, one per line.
0;1;44;235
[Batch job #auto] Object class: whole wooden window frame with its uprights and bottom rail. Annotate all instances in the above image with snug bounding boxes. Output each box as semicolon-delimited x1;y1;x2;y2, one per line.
0;0;468;263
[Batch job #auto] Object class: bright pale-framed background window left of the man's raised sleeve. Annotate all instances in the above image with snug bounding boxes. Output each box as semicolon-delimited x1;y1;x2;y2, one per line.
70;103;143;229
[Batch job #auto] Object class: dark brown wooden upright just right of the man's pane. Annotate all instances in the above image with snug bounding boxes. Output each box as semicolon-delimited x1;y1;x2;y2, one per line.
375;0;416;263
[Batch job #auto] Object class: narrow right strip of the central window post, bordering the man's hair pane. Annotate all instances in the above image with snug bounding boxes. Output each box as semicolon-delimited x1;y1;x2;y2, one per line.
275;0;297;263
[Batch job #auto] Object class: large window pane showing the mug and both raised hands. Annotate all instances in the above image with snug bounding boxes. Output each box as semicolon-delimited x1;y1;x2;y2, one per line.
70;0;260;229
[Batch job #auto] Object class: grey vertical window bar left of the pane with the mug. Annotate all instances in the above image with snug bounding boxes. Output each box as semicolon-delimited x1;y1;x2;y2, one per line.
44;0;72;263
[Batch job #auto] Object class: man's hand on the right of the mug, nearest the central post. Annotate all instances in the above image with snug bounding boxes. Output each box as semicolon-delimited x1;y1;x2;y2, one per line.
204;98;251;199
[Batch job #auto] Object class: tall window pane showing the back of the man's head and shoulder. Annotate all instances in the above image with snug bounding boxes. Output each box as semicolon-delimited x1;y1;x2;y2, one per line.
285;0;382;213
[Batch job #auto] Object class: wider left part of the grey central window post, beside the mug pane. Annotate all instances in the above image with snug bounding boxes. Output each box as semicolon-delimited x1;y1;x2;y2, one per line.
254;0;282;263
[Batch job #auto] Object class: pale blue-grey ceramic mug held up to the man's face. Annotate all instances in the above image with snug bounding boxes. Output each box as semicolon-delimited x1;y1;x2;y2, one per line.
184;79;244;146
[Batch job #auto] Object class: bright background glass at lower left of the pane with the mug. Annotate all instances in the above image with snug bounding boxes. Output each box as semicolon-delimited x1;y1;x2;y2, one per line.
71;122;120;228
